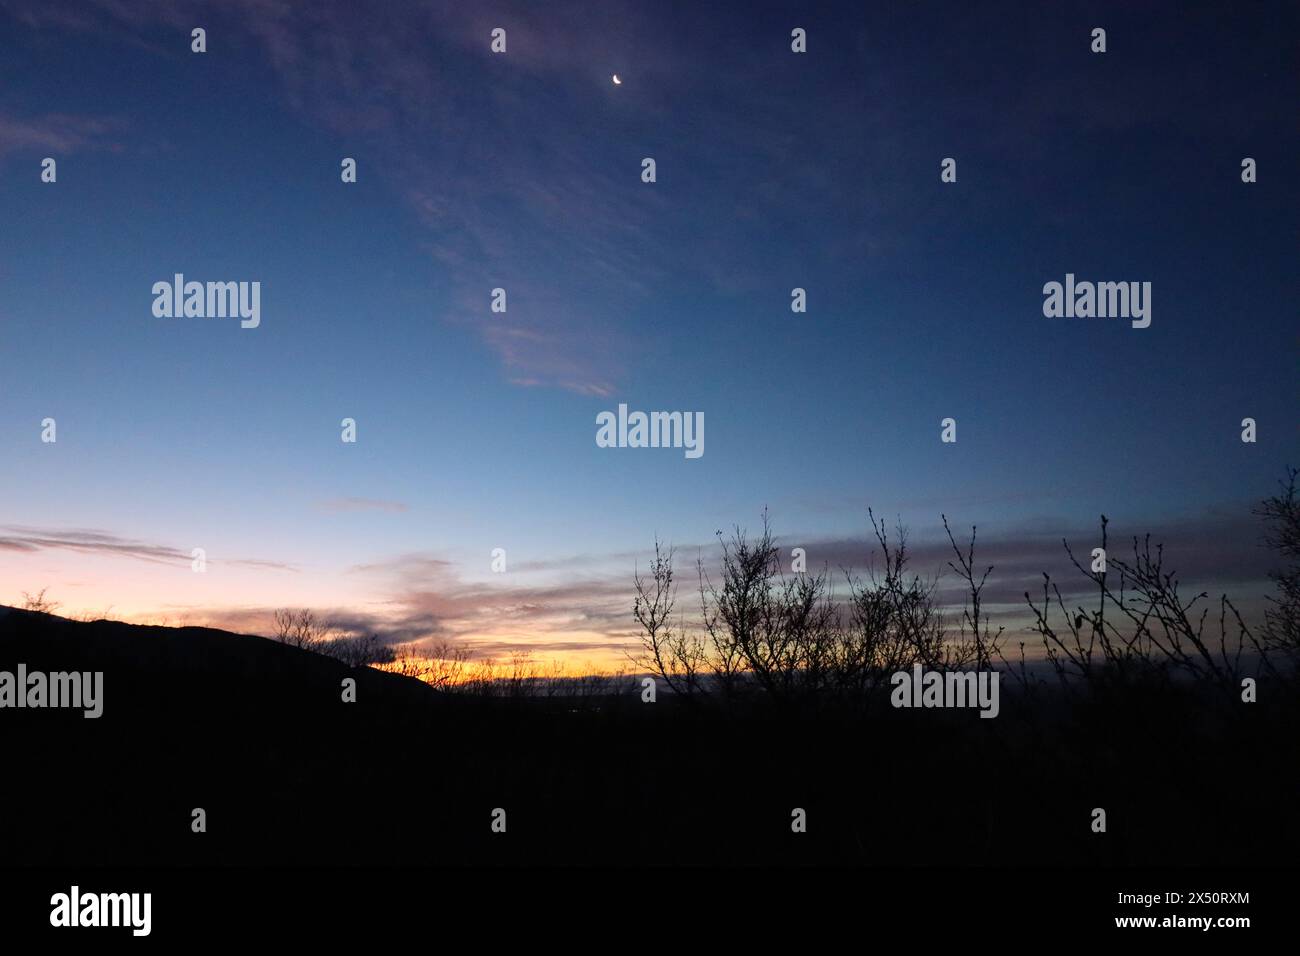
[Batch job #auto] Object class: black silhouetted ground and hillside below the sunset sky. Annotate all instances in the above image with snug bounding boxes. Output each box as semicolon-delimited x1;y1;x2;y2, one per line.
0;611;1300;866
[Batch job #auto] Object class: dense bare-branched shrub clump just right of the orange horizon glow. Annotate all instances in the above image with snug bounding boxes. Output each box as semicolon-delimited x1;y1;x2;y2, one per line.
633;510;1001;700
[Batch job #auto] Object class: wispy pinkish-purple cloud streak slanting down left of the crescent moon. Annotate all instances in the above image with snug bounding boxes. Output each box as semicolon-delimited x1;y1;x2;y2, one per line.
246;7;649;397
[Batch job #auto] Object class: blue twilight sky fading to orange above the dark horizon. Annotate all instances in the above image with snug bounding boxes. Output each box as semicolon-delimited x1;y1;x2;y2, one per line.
0;0;1300;665
